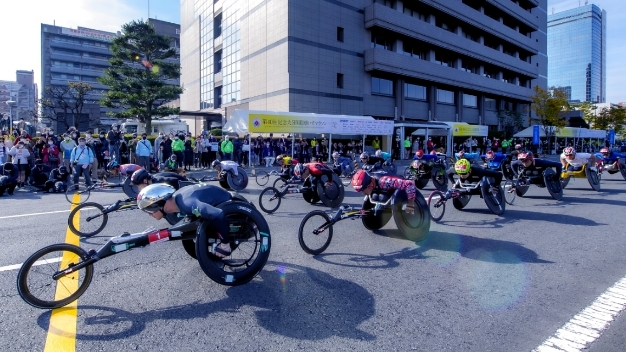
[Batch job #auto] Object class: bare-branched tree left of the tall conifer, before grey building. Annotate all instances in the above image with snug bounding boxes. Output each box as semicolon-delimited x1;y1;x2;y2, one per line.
39;82;95;130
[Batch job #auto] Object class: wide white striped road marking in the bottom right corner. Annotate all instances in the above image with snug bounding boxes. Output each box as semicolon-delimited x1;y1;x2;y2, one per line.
533;277;626;352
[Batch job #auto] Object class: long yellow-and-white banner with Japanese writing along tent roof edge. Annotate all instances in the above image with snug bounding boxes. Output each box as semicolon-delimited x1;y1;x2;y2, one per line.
248;113;393;135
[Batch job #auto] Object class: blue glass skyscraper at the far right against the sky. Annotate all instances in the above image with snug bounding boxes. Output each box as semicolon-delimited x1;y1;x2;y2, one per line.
548;4;606;103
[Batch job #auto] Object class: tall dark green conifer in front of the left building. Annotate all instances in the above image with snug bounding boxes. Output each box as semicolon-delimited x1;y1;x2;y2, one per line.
98;21;183;131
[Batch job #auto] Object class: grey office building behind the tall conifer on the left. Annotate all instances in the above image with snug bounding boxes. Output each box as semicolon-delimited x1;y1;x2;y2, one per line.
41;19;180;132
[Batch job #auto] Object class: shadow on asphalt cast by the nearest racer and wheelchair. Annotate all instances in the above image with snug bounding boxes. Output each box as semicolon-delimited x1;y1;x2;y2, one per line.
37;262;376;342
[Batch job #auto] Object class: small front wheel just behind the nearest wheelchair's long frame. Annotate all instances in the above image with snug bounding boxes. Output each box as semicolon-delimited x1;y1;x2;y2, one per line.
67;202;109;237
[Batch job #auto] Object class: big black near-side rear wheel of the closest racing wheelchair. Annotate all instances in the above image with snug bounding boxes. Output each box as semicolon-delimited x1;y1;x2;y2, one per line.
196;201;271;286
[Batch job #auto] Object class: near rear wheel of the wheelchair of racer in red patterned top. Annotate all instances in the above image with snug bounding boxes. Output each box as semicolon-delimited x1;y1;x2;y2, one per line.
391;191;430;242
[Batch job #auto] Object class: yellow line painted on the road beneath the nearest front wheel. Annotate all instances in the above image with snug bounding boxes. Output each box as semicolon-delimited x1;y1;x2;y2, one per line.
44;194;80;352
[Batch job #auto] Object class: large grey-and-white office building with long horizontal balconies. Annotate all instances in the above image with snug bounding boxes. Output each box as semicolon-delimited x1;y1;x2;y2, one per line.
181;0;547;137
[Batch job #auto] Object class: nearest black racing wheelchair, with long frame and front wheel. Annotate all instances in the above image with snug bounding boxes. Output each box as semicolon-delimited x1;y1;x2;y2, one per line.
17;195;271;309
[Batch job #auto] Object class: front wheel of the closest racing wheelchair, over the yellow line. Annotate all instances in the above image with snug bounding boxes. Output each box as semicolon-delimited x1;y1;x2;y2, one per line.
17;243;93;309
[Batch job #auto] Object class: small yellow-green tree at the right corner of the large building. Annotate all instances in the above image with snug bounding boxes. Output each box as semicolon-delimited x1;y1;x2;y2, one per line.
530;86;570;148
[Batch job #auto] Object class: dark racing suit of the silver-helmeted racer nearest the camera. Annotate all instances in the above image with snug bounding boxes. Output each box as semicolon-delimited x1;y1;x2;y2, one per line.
172;185;232;243
